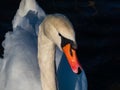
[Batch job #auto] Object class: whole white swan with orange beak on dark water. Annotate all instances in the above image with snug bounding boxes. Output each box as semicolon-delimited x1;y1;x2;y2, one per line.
0;0;87;90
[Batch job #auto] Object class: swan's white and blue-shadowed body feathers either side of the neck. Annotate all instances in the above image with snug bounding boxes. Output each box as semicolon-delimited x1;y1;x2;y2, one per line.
0;0;87;90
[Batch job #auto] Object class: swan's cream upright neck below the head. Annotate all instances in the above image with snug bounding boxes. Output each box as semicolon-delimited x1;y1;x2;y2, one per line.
38;27;56;90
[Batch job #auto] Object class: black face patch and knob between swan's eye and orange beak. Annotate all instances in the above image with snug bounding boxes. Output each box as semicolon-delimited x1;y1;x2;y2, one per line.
59;33;77;52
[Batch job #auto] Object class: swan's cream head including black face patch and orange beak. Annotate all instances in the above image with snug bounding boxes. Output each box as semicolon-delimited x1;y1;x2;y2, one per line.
42;14;82;74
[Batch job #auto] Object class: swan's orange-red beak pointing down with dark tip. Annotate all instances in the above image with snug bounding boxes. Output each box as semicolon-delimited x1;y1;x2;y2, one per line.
62;44;82;74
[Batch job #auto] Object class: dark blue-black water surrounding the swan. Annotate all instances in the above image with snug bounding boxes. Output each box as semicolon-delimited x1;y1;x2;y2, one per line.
0;0;120;90
